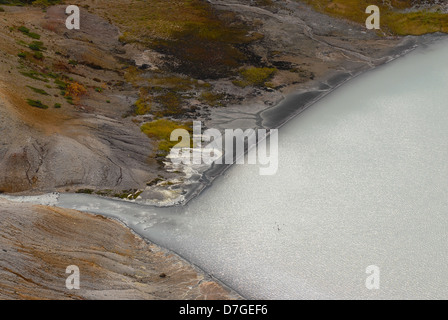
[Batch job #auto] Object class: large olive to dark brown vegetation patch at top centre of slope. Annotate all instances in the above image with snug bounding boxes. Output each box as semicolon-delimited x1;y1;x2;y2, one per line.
96;0;263;79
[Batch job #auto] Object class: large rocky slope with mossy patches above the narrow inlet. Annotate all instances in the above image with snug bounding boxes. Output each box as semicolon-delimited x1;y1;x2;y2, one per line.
0;0;444;204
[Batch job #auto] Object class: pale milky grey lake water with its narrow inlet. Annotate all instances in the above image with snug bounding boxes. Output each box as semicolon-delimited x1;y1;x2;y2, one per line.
6;41;448;299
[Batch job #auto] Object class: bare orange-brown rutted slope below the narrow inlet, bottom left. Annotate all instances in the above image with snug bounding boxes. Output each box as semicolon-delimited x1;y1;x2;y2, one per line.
0;200;240;300
